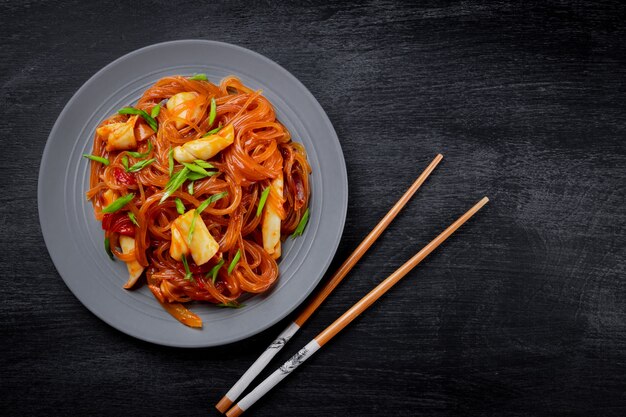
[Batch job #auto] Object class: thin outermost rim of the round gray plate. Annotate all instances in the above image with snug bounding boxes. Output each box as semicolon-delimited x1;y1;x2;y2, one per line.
37;39;349;348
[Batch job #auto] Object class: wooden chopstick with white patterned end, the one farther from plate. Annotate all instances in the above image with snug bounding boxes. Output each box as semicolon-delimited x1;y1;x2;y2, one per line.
226;197;489;417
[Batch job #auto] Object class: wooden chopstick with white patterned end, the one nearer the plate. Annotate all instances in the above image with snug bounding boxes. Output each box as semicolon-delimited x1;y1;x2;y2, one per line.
215;154;443;413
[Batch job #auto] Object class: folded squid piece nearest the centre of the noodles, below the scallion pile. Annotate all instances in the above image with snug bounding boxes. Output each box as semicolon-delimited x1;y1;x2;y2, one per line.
170;209;219;265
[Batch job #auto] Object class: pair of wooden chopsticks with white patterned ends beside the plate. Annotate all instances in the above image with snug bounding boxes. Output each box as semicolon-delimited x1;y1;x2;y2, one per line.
216;155;489;417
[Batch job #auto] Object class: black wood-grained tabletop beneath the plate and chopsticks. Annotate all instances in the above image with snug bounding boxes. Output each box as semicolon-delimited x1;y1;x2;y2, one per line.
0;1;626;416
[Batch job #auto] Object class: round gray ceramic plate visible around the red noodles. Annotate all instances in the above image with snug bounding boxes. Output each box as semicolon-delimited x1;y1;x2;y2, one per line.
38;40;348;347
